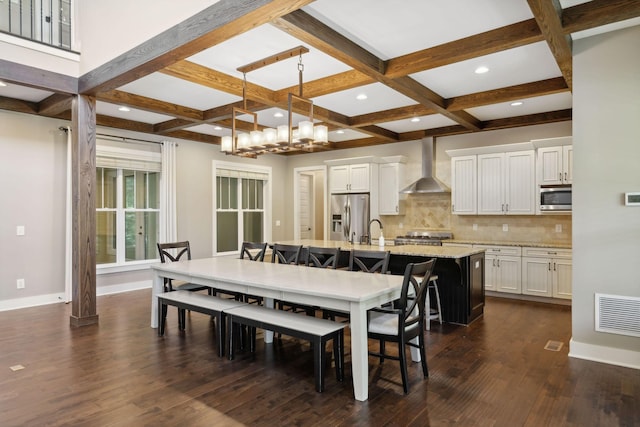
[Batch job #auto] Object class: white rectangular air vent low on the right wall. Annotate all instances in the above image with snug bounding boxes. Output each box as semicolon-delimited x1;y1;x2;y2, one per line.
596;294;640;337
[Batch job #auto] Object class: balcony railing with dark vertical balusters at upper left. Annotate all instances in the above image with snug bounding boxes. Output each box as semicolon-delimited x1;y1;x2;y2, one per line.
0;0;73;50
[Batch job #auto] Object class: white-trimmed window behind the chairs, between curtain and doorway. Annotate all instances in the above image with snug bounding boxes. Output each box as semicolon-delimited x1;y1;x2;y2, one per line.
214;166;270;253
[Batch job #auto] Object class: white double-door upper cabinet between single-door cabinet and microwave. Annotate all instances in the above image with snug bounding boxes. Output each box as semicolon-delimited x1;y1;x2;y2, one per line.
478;150;536;215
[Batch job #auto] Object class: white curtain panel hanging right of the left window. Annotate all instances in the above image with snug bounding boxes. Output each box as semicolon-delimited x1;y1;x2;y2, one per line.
160;141;178;242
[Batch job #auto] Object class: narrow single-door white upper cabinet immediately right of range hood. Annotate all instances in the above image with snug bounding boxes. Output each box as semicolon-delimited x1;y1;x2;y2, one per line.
451;155;478;215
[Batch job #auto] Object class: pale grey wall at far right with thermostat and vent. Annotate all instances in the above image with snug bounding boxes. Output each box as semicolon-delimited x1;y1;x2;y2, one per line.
571;26;640;368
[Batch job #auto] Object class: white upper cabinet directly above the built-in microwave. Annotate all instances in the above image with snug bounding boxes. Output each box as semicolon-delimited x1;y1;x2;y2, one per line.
532;137;573;185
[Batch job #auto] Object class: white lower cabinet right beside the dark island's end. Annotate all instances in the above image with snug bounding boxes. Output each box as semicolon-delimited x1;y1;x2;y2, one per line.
473;245;522;294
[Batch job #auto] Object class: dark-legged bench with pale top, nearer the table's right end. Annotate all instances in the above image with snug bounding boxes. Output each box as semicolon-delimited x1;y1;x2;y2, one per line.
225;305;346;392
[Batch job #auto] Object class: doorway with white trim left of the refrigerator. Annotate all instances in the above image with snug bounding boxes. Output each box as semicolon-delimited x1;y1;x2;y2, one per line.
293;166;327;240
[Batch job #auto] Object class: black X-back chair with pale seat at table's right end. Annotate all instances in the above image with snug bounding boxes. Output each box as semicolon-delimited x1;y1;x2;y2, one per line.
367;258;436;394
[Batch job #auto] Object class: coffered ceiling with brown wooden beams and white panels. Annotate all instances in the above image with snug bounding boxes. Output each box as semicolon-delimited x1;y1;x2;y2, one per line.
0;0;640;154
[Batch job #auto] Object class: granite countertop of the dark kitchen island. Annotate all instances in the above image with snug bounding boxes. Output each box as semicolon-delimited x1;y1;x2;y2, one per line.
276;240;484;259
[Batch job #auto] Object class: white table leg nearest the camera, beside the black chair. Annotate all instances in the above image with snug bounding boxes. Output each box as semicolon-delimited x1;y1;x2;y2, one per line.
349;302;369;401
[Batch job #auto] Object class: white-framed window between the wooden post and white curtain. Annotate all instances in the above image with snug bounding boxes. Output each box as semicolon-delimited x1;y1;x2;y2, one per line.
96;167;160;264
